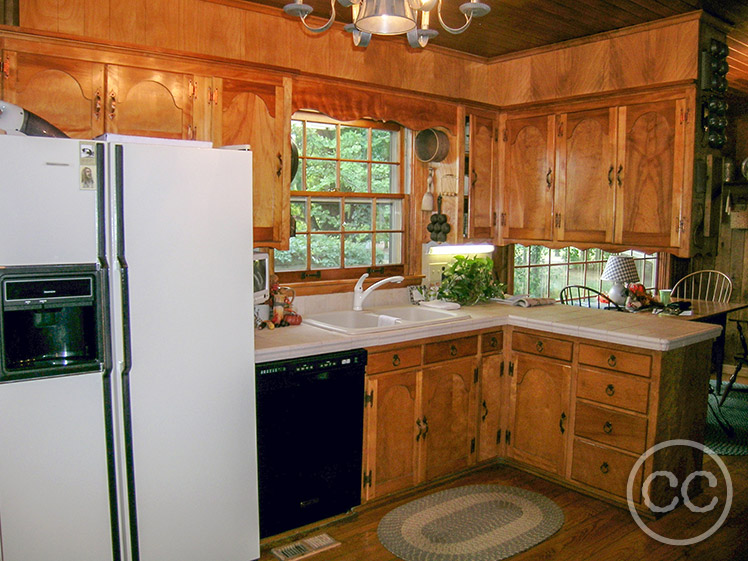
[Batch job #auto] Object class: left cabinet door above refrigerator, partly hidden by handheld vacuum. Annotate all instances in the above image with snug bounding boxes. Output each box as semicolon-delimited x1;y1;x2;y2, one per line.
2;51;104;138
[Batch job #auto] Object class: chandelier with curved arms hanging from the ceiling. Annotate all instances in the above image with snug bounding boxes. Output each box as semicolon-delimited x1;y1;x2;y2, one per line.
283;0;491;48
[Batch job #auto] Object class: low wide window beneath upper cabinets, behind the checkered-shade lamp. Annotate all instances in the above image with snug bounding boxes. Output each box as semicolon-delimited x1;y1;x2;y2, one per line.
514;244;659;299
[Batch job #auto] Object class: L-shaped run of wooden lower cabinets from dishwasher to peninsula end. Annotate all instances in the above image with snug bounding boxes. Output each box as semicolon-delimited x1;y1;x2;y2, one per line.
362;327;711;512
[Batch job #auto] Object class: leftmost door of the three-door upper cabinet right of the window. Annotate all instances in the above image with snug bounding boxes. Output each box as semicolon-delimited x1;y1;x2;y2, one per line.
501;115;555;241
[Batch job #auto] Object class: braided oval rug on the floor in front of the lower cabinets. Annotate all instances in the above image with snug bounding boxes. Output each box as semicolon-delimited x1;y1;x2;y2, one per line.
377;485;564;561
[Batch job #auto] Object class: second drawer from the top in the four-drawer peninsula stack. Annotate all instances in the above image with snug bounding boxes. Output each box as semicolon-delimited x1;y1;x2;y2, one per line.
577;368;649;413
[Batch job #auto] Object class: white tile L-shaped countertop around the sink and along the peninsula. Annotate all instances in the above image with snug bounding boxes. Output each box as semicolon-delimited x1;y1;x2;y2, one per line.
255;303;722;363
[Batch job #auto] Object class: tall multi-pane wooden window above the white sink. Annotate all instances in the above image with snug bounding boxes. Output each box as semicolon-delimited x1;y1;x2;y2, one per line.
275;113;405;282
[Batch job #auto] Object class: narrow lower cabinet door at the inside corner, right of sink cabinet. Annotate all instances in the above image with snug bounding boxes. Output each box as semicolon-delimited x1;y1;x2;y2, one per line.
478;354;505;462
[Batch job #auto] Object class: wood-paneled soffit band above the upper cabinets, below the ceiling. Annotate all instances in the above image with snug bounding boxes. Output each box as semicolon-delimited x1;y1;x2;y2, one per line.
19;0;700;106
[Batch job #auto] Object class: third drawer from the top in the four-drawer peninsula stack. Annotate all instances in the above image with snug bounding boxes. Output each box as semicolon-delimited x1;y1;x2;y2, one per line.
574;400;647;453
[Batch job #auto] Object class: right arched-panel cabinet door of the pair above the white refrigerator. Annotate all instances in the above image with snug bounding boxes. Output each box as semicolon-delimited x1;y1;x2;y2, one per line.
106;65;197;140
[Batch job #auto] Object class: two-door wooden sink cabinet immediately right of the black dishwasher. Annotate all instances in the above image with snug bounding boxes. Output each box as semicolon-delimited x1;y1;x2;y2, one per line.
362;335;478;500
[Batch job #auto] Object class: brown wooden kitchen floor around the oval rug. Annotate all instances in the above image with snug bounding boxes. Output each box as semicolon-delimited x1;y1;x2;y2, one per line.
261;456;748;561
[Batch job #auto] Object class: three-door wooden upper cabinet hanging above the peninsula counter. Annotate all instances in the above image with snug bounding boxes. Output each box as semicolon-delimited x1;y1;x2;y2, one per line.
500;88;694;257
